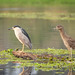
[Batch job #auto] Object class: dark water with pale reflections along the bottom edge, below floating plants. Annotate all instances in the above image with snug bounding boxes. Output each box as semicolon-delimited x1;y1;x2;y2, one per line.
0;62;75;75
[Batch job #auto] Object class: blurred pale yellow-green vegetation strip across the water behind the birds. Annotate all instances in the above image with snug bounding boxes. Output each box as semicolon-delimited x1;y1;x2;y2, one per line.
0;12;75;20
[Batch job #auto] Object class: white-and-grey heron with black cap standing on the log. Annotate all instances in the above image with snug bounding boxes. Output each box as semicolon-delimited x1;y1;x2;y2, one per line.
8;25;32;51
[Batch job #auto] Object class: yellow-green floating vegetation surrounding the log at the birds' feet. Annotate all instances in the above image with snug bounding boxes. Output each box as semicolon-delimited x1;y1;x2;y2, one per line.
0;48;75;73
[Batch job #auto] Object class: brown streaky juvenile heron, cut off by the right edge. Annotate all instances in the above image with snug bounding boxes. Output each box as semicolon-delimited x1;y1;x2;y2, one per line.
56;25;75;57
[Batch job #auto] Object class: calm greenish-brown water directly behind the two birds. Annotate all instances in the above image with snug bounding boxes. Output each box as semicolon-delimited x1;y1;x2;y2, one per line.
0;18;75;50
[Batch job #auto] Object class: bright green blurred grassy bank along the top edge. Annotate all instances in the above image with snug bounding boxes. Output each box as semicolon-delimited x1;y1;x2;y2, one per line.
0;0;75;7
